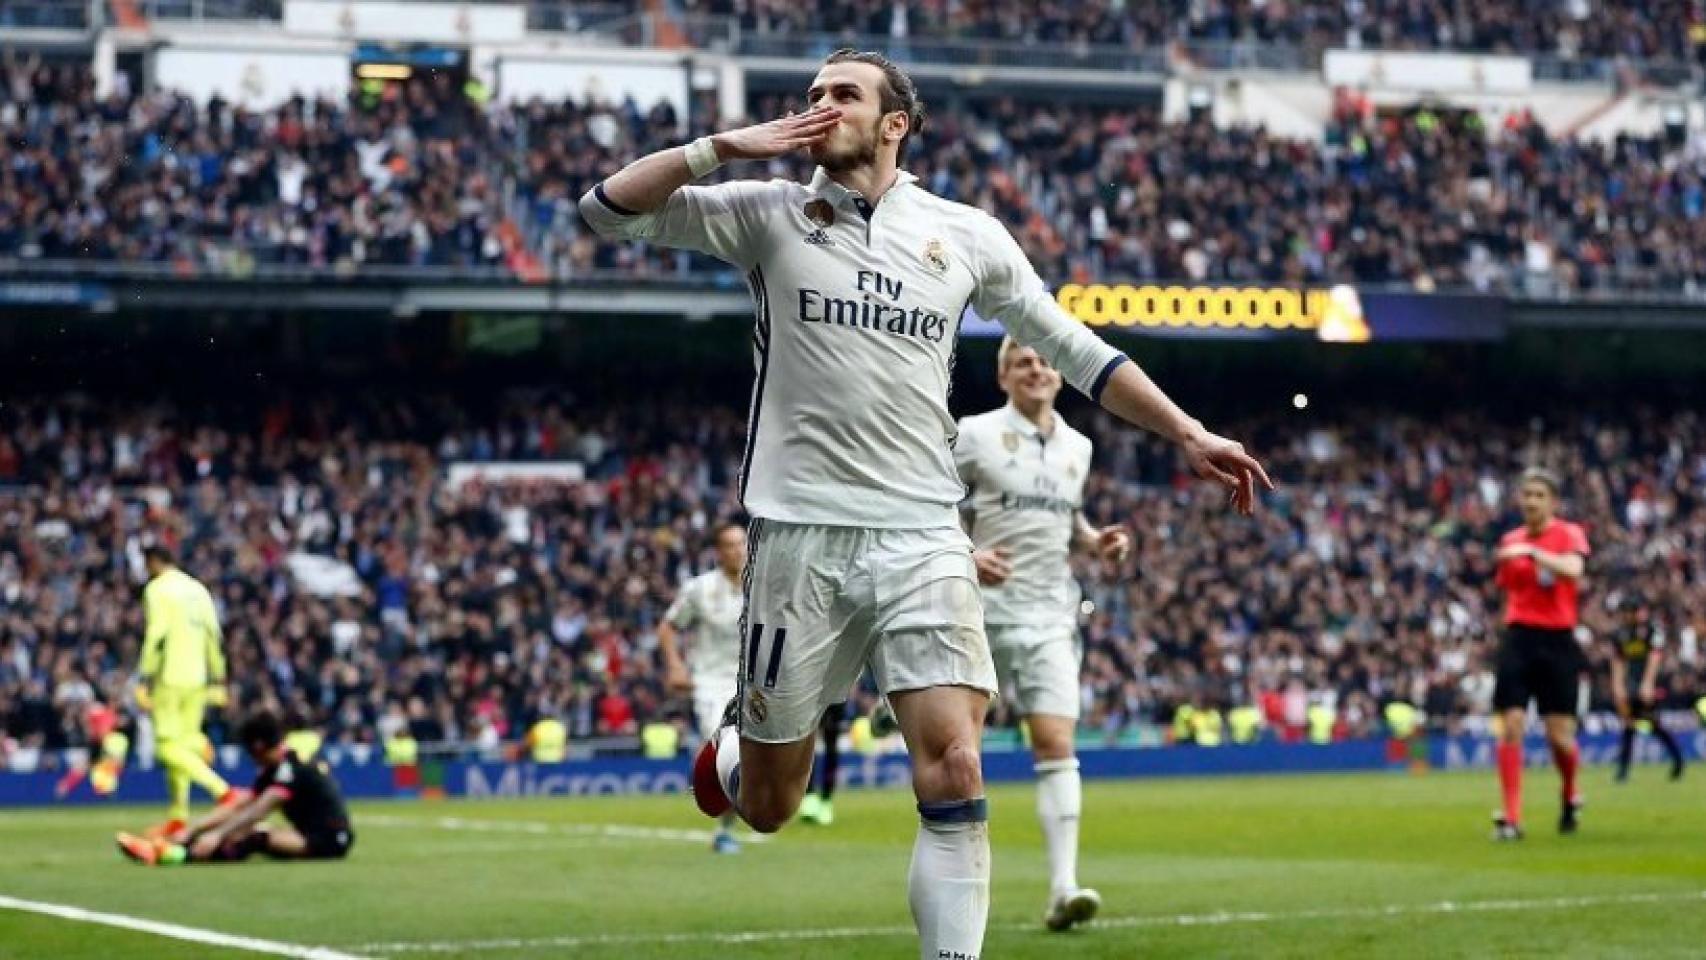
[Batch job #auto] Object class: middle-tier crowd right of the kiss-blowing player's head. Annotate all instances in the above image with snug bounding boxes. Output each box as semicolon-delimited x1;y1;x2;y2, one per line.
747;97;1706;295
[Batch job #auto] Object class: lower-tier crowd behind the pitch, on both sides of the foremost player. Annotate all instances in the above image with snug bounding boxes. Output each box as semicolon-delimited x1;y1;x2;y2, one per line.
0;392;1706;757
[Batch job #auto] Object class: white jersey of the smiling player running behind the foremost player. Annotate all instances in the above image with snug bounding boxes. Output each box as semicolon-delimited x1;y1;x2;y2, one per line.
954;404;1090;624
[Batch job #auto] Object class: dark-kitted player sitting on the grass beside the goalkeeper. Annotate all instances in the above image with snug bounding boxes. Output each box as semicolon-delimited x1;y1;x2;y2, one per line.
118;711;355;866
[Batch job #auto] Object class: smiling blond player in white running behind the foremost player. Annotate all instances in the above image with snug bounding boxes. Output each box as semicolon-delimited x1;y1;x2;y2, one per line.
954;338;1131;931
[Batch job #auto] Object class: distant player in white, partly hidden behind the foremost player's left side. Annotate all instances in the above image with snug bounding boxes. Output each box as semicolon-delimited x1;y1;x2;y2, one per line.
657;523;746;853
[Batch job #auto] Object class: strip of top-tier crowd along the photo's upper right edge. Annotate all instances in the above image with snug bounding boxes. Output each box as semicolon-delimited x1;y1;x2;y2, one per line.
686;0;1706;60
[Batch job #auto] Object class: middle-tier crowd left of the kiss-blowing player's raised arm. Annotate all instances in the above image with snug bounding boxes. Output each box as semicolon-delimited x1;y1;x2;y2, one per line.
0;51;726;276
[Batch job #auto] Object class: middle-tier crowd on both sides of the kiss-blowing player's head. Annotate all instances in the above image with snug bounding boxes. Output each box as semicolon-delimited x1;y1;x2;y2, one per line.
0;58;1706;295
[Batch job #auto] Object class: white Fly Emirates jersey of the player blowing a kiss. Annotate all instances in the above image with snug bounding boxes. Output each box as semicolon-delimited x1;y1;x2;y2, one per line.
580;163;1124;529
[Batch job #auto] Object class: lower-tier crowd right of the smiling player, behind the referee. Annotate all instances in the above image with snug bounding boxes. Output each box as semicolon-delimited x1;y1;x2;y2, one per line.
1082;411;1706;738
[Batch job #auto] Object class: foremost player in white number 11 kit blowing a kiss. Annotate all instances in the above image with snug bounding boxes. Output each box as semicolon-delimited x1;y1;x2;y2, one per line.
580;51;1268;960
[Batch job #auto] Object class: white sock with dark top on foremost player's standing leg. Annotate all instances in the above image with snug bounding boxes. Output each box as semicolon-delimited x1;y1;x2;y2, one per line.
908;798;989;960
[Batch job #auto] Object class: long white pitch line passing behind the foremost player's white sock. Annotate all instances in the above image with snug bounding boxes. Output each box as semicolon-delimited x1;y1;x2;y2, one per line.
342;890;1706;953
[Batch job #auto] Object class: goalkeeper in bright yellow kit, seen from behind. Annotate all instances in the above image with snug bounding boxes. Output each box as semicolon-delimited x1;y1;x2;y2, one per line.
136;546;242;837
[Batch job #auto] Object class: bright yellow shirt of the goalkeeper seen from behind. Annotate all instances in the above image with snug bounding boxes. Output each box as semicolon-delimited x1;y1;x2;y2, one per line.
138;568;225;689
